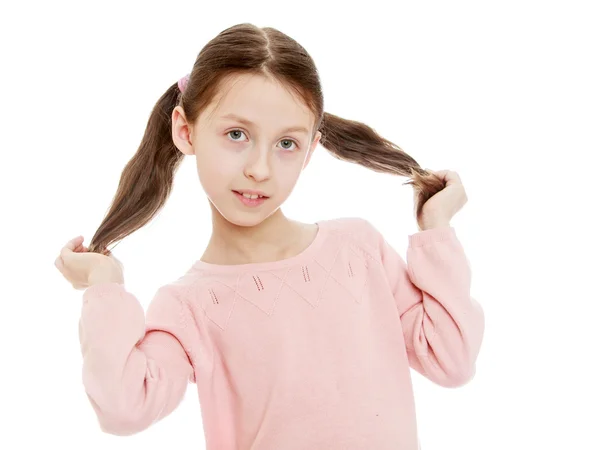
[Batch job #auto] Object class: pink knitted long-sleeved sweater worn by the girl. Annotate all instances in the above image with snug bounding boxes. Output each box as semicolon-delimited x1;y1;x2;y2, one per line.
79;218;484;450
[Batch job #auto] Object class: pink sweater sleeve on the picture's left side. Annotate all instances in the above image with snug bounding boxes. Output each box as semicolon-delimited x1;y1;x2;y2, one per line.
79;282;195;436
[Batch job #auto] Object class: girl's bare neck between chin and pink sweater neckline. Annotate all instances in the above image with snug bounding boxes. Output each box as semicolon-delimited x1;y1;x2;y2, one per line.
201;203;305;264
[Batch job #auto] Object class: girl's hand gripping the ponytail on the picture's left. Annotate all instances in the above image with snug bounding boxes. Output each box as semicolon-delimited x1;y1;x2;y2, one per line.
54;236;124;290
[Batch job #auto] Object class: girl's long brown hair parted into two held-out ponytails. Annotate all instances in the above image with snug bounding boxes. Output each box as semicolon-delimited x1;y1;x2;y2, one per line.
88;23;445;254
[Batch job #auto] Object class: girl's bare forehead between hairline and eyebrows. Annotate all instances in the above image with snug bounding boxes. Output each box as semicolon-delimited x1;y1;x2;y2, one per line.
209;74;312;127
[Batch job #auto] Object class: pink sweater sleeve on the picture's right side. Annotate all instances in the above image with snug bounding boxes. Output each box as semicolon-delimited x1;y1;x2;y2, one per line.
375;221;485;388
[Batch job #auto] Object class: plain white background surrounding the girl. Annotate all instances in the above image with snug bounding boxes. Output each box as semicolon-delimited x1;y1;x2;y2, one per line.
0;0;600;450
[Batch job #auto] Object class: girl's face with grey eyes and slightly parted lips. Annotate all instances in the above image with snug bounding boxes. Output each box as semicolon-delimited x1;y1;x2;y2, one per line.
173;74;321;226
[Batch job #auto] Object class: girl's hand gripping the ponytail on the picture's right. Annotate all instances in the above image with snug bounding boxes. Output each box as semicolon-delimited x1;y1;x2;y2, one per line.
415;170;468;230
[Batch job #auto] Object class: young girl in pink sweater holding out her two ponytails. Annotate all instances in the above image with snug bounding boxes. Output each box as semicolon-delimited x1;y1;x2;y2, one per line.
56;24;484;450
